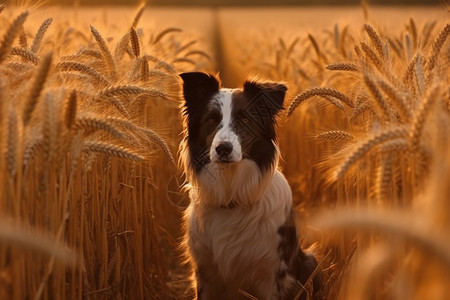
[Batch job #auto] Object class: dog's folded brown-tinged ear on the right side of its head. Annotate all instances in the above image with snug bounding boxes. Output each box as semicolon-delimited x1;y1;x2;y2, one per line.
244;80;287;115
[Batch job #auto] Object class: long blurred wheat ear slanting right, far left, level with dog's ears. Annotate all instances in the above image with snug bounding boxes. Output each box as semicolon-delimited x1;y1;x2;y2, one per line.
22;53;53;125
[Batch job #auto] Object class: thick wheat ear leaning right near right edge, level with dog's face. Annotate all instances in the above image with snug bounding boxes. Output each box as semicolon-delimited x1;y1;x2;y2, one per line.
409;87;439;149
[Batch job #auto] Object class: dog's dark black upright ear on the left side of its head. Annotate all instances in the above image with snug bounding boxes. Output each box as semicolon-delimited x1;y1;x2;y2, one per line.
180;72;220;110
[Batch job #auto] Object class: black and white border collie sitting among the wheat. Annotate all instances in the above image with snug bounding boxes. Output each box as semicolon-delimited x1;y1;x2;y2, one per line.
180;72;318;300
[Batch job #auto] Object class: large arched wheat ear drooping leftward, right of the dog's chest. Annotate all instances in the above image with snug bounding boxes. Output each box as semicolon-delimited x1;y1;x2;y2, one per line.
335;127;408;179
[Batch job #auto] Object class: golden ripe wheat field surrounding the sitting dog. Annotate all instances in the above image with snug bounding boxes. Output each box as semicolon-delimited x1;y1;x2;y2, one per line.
0;1;450;300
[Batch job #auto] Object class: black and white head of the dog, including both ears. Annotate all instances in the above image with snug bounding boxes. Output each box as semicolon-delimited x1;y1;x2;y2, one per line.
180;72;287;173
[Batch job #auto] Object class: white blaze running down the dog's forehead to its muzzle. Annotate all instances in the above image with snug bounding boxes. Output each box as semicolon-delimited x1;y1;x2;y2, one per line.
209;89;242;162
